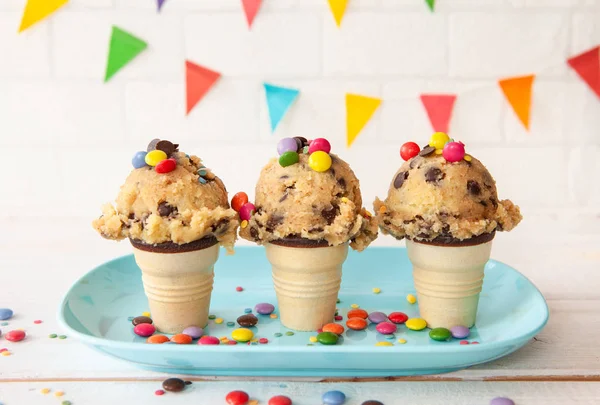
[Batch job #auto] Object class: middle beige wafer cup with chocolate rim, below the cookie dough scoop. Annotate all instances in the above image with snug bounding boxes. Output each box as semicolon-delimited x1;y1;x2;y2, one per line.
265;239;348;331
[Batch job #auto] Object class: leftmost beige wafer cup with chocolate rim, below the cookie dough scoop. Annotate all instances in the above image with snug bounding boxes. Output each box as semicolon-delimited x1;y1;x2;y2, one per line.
131;237;219;334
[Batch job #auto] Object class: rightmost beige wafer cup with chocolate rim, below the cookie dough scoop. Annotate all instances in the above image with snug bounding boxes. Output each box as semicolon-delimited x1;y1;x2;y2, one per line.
406;234;494;329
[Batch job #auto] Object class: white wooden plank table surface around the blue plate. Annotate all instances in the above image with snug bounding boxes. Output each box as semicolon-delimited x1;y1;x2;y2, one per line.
0;219;600;405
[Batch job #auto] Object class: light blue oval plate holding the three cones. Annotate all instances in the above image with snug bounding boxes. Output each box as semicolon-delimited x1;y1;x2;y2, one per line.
59;247;548;377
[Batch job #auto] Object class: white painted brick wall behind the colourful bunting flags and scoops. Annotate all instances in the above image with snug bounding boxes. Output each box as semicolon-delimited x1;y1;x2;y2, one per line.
0;0;600;244
